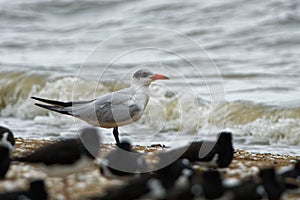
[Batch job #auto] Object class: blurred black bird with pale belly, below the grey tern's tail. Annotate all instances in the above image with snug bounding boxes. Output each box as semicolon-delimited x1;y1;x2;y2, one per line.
12;128;101;178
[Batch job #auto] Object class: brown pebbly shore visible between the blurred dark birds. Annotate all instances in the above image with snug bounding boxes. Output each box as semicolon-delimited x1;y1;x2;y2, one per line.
0;138;300;199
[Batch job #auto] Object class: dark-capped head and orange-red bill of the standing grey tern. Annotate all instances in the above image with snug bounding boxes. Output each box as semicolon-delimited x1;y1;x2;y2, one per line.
132;69;170;86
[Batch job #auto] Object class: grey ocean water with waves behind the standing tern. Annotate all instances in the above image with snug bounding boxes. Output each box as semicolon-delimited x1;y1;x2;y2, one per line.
0;0;300;155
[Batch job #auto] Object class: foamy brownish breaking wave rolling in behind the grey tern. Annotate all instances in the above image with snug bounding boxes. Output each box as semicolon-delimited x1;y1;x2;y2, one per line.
0;72;300;145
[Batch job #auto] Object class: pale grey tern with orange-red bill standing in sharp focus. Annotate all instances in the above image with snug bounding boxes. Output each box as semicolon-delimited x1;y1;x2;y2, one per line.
31;69;169;145
